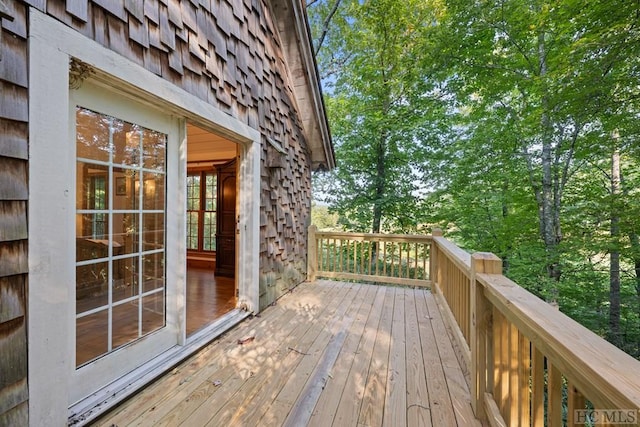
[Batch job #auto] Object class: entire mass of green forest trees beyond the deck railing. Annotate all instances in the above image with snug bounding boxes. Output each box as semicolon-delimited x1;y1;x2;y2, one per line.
307;0;640;357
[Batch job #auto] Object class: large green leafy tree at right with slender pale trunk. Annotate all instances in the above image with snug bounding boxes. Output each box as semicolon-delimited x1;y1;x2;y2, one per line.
430;0;638;301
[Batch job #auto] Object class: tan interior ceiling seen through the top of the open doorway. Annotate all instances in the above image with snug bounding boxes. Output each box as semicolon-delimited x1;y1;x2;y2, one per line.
187;123;237;162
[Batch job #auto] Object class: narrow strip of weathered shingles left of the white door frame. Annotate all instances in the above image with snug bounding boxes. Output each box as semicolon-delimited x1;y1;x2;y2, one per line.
0;2;28;425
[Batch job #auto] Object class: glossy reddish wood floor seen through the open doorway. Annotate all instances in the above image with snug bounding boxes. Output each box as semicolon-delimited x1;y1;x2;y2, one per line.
187;267;236;336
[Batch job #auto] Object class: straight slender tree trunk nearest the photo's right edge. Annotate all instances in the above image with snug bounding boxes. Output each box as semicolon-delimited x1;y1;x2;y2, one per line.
609;142;622;347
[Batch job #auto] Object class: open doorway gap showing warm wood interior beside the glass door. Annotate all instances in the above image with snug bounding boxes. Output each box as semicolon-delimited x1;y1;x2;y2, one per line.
185;124;238;336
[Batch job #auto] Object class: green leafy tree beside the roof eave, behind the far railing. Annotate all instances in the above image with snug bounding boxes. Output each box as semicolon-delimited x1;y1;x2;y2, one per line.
312;0;438;232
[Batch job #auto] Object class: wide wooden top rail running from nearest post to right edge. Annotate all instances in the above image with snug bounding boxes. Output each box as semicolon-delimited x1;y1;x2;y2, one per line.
476;274;640;416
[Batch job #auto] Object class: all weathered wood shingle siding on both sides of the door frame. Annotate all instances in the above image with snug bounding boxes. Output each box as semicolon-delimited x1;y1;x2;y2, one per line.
0;0;320;425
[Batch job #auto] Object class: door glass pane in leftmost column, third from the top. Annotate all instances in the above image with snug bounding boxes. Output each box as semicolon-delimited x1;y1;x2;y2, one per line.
76;213;109;261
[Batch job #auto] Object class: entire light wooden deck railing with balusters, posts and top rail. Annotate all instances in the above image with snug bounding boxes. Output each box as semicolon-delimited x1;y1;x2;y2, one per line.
308;226;640;427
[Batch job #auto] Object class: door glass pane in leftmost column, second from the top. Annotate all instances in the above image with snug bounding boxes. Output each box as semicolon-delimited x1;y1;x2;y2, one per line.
76;162;109;210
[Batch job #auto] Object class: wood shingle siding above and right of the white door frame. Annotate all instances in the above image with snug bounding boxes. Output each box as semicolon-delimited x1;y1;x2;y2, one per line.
45;0;311;307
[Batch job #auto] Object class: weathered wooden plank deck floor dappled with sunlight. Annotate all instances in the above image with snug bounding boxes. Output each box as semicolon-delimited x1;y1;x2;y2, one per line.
97;280;480;427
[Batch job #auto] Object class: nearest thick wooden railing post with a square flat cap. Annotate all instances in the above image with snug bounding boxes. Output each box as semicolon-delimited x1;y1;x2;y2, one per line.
469;252;502;420
